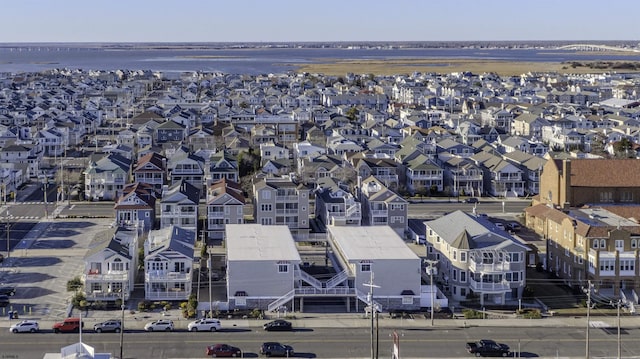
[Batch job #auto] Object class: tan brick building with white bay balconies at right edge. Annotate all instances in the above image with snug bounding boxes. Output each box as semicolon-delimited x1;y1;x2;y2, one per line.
525;204;640;300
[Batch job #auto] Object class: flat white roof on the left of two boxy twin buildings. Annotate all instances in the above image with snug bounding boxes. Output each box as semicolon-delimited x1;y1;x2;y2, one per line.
225;224;301;262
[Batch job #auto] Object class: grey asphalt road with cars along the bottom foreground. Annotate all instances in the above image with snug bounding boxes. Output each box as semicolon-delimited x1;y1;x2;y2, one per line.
0;323;640;358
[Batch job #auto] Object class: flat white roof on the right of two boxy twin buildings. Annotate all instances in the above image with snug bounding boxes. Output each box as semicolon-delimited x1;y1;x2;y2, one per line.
327;226;420;261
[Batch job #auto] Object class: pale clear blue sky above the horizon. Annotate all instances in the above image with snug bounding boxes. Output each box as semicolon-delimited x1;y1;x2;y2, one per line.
5;0;640;42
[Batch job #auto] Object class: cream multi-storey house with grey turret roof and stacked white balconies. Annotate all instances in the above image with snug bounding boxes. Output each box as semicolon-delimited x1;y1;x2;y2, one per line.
425;211;528;306
